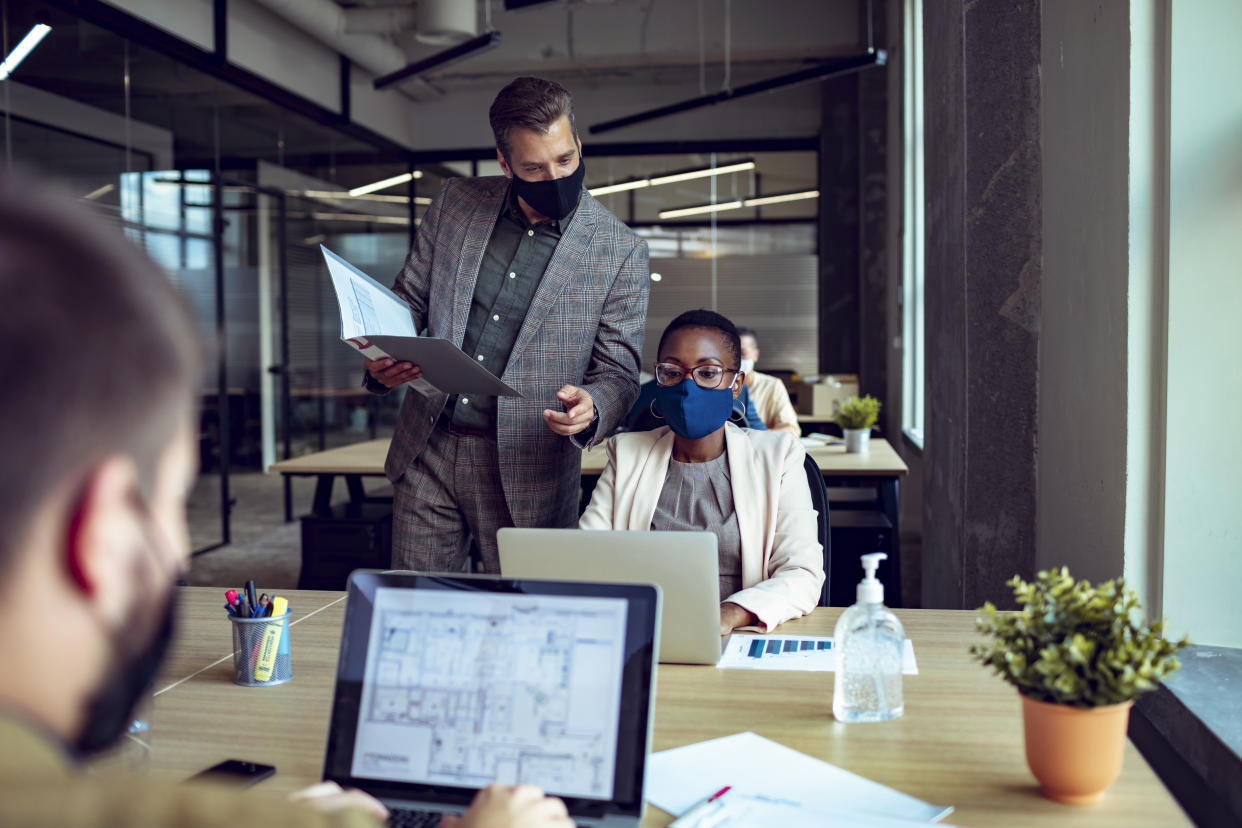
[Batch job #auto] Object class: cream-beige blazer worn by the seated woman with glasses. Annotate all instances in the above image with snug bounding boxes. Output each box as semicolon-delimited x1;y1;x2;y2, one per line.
578;423;823;629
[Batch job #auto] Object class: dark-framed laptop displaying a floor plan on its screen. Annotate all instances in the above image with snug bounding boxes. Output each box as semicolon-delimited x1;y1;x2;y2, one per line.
323;571;661;827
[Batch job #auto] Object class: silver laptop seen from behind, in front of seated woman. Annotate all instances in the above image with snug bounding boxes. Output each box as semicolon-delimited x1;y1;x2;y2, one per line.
496;529;722;664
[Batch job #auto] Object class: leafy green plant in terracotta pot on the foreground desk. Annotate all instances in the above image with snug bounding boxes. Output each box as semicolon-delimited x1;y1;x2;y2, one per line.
970;567;1187;804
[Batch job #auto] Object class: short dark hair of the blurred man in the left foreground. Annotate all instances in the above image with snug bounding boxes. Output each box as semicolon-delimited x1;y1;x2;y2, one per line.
0;179;201;574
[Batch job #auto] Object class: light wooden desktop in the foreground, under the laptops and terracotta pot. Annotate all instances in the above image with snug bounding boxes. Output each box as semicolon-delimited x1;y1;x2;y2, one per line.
140;587;1191;828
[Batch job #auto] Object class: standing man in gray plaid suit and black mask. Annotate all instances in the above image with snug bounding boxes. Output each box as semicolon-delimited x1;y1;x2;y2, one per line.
365;77;650;572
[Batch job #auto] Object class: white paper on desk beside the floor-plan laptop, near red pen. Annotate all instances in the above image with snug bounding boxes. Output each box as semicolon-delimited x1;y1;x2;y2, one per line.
646;732;953;826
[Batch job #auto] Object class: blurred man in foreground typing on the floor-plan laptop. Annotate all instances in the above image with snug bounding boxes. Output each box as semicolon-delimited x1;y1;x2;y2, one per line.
0;179;571;828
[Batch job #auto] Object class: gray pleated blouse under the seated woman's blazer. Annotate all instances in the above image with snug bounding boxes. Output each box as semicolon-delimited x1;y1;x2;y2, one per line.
651;452;741;601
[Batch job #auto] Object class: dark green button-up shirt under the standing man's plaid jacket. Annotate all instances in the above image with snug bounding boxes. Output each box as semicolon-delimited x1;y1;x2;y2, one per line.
447;185;576;428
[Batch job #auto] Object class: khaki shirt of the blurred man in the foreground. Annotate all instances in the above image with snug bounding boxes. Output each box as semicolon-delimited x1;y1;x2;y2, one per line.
0;713;378;828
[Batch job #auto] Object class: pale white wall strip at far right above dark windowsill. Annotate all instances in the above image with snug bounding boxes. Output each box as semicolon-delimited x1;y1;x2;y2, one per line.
1164;0;1242;647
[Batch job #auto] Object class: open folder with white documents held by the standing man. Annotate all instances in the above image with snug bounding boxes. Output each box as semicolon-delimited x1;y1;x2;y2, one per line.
319;245;522;397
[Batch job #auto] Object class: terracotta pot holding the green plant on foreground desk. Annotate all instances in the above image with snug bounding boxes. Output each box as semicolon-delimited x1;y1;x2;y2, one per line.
1022;695;1134;804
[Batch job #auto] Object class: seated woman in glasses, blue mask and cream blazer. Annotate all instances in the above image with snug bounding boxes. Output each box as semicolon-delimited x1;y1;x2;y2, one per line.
579;310;823;636
